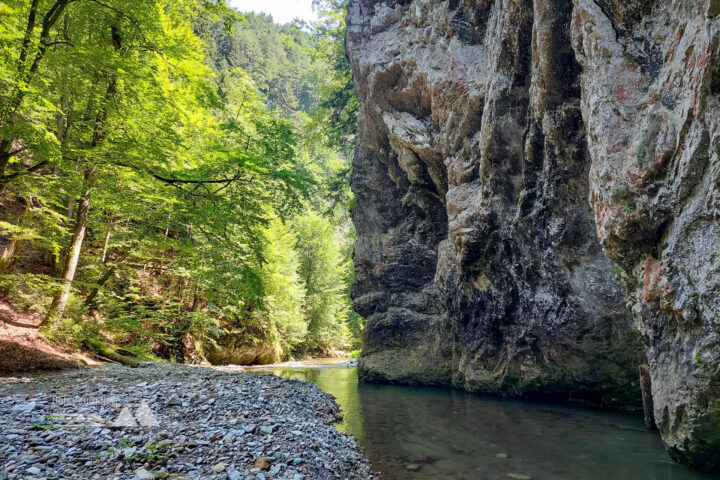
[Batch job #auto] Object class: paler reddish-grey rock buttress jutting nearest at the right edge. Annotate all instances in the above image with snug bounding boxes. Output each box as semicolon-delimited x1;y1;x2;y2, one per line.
572;0;720;469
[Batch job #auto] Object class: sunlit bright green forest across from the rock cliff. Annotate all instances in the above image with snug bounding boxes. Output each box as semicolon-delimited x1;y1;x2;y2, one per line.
0;0;364;364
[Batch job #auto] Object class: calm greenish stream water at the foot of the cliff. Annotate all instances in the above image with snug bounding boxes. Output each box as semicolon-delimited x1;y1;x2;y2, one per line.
253;366;716;480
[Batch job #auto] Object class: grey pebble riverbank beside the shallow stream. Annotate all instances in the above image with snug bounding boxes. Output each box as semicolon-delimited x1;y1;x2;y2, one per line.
0;364;374;480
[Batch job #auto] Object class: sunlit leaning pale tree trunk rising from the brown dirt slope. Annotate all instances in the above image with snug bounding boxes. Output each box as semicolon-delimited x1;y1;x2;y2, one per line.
40;167;97;329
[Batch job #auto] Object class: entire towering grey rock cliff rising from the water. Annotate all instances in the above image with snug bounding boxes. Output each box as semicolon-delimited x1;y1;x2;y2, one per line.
347;0;720;468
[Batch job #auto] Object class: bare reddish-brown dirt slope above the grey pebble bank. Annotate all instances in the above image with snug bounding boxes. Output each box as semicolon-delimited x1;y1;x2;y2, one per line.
0;300;101;375
